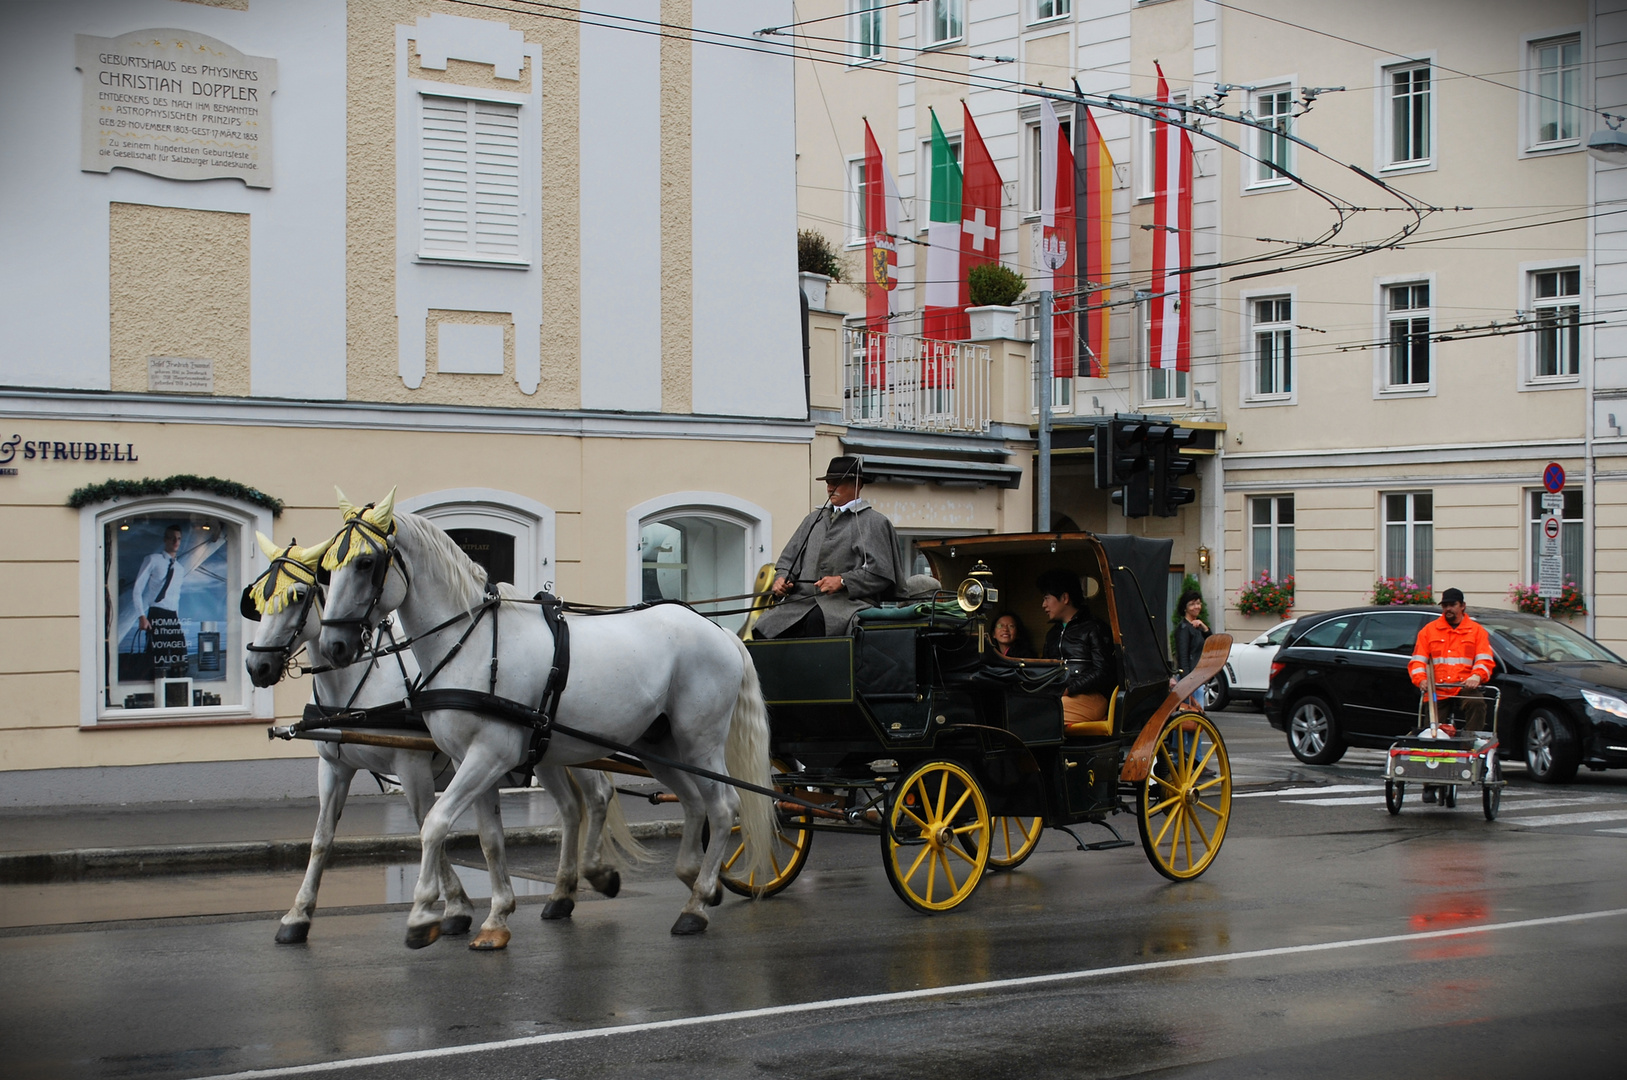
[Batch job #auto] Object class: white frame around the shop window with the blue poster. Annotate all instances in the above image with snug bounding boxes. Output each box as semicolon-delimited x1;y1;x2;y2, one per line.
78;491;275;730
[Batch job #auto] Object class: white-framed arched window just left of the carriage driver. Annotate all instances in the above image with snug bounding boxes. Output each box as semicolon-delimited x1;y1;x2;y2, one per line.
628;491;773;631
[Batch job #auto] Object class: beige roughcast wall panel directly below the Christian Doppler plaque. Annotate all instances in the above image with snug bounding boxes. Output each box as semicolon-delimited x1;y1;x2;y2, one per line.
107;203;251;395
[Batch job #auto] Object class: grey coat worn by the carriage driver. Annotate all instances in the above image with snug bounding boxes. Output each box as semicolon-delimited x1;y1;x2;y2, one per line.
757;499;905;638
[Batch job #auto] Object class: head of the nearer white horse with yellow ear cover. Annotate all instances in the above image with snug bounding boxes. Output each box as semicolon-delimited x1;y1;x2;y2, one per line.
322;488;407;667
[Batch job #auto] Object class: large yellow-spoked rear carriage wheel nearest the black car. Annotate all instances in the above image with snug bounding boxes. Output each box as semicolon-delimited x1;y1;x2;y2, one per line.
1136;712;1232;882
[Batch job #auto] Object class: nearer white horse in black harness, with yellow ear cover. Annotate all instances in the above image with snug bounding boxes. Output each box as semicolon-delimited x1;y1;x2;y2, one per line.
322;491;774;948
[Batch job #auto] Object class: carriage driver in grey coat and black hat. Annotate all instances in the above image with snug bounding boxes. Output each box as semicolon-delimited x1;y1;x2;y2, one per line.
753;455;905;638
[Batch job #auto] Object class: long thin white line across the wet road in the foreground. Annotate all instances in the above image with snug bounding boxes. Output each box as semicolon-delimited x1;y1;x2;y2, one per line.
200;908;1627;1080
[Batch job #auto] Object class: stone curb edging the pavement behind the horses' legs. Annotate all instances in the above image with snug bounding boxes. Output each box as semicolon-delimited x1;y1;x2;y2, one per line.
0;821;683;885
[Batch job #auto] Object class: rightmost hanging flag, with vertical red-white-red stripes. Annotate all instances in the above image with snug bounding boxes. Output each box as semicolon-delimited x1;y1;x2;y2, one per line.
1147;67;1193;371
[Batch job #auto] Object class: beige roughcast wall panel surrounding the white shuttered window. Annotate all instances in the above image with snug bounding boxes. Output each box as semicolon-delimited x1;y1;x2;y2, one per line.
345;0;582;408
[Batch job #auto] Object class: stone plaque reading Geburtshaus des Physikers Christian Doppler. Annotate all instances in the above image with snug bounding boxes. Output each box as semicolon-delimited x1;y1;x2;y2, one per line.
75;29;277;187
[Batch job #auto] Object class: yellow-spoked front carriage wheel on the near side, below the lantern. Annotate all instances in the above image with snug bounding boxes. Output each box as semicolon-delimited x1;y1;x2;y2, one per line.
882;761;992;914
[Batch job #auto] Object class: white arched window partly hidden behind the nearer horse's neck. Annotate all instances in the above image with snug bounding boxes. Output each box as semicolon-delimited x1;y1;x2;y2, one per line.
395;488;556;595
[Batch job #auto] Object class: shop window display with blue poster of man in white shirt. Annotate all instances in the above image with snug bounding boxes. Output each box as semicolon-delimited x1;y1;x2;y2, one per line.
98;511;246;721
